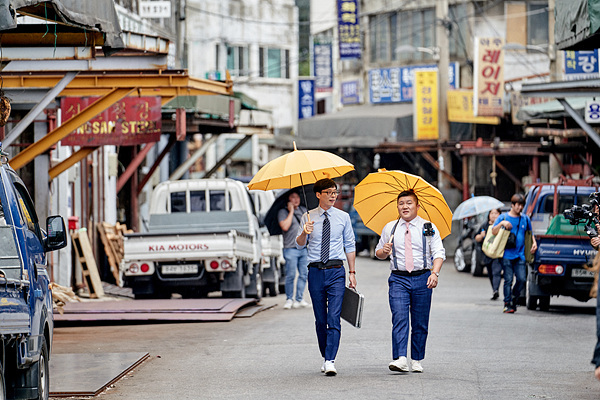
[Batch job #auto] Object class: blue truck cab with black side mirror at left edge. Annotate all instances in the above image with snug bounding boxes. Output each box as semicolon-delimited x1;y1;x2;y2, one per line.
0;144;67;399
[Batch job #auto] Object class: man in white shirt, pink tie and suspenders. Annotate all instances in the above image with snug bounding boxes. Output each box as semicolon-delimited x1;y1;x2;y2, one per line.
375;190;446;372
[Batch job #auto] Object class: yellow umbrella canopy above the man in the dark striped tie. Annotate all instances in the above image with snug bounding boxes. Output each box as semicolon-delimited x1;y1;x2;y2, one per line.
248;143;354;190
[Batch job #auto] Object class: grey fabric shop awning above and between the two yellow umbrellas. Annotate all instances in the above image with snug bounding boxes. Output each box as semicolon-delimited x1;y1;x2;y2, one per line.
296;104;413;149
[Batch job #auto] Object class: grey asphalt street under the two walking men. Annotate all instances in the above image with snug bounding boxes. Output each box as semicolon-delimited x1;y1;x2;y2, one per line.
51;257;600;400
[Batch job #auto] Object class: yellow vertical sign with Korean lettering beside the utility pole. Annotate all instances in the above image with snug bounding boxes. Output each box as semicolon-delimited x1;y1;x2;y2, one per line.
413;69;439;140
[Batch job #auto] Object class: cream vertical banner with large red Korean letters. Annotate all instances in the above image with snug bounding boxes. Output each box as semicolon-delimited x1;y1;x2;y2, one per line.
473;37;504;117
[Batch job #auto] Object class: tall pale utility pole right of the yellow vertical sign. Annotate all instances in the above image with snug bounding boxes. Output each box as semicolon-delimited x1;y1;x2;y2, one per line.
435;0;452;189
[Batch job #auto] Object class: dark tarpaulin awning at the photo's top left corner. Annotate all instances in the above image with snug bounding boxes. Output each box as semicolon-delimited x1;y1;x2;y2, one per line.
0;0;124;54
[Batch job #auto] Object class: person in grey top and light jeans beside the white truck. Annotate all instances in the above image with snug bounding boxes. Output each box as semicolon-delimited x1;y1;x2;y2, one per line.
277;190;310;310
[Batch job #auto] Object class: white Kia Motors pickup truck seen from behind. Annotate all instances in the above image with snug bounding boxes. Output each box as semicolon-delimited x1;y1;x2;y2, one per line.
120;179;263;298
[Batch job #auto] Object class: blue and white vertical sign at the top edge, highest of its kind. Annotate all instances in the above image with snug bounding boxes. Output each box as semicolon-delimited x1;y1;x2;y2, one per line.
337;0;361;60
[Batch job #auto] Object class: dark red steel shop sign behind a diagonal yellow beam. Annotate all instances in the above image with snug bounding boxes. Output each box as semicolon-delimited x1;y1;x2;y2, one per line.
60;97;162;146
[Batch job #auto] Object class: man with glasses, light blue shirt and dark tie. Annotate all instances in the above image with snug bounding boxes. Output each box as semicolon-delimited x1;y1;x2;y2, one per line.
296;178;356;376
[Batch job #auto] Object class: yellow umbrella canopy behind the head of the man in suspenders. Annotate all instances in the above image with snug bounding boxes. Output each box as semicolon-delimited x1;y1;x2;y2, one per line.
354;169;452;239
